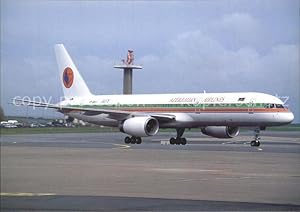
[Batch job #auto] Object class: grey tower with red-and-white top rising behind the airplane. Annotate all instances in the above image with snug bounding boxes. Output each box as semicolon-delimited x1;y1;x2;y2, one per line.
114;49;143;94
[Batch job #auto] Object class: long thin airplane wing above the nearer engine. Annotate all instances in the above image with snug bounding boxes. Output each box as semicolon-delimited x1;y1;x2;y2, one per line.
13;98;176;122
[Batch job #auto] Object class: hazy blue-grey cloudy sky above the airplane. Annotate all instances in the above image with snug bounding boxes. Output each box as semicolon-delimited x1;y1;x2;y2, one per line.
0;0;300;122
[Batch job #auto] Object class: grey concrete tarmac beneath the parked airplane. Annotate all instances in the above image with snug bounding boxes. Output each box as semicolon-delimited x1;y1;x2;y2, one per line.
1;132;300;211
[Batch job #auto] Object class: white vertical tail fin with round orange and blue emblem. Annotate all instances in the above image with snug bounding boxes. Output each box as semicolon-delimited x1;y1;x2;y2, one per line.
54;44;92;99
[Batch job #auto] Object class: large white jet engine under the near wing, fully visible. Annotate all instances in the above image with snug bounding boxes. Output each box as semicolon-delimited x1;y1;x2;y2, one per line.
120;116;159;137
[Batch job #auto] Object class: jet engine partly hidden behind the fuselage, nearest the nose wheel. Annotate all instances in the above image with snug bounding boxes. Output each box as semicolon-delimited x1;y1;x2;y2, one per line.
201;126;240;138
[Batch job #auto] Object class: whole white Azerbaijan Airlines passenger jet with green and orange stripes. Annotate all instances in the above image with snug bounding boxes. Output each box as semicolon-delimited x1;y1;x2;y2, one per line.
14;44;294;147
